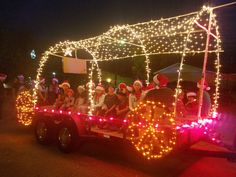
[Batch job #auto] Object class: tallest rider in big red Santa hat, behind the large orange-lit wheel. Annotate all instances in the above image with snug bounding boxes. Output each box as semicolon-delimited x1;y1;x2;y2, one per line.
144;74;174;111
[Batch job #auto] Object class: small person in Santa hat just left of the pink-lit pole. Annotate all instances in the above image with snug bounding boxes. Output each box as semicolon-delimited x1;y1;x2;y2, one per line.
185;92;198;116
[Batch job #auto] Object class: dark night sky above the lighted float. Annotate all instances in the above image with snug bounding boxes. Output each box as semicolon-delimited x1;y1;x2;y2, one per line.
0;0;236;77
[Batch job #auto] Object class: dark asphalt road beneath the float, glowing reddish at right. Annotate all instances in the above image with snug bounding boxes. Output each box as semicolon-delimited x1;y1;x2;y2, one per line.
0;102;236;177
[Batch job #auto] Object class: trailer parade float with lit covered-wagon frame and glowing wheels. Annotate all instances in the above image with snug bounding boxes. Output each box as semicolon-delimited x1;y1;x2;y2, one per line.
17;3;236;159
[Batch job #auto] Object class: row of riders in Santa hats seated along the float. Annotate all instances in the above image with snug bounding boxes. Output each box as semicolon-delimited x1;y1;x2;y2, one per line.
38;74;211;118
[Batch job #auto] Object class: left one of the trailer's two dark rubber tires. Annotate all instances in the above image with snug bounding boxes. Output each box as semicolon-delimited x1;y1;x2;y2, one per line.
34;119;52;145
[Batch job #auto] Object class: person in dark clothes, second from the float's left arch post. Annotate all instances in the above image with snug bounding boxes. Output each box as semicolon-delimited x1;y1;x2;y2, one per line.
48;77;59;105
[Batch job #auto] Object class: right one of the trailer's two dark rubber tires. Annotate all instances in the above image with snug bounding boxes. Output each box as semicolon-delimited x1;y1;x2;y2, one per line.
57;124;79;153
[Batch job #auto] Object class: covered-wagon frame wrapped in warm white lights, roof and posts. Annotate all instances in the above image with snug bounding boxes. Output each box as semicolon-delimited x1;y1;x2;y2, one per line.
33;6;222;117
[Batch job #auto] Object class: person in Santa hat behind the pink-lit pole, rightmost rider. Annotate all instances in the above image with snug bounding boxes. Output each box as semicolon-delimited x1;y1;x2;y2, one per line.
197;80;211;117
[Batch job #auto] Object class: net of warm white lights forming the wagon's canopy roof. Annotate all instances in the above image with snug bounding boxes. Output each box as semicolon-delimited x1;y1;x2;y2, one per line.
49;7;221;61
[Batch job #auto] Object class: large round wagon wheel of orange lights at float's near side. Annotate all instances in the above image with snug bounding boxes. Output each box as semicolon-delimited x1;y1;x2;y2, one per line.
127;101;176;159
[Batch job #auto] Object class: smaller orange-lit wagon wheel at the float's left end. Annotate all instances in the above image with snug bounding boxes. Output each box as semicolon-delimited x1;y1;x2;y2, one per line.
16;91;34;126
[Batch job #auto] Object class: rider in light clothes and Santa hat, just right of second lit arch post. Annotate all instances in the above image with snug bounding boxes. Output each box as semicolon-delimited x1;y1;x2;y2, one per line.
93;85;105;115
